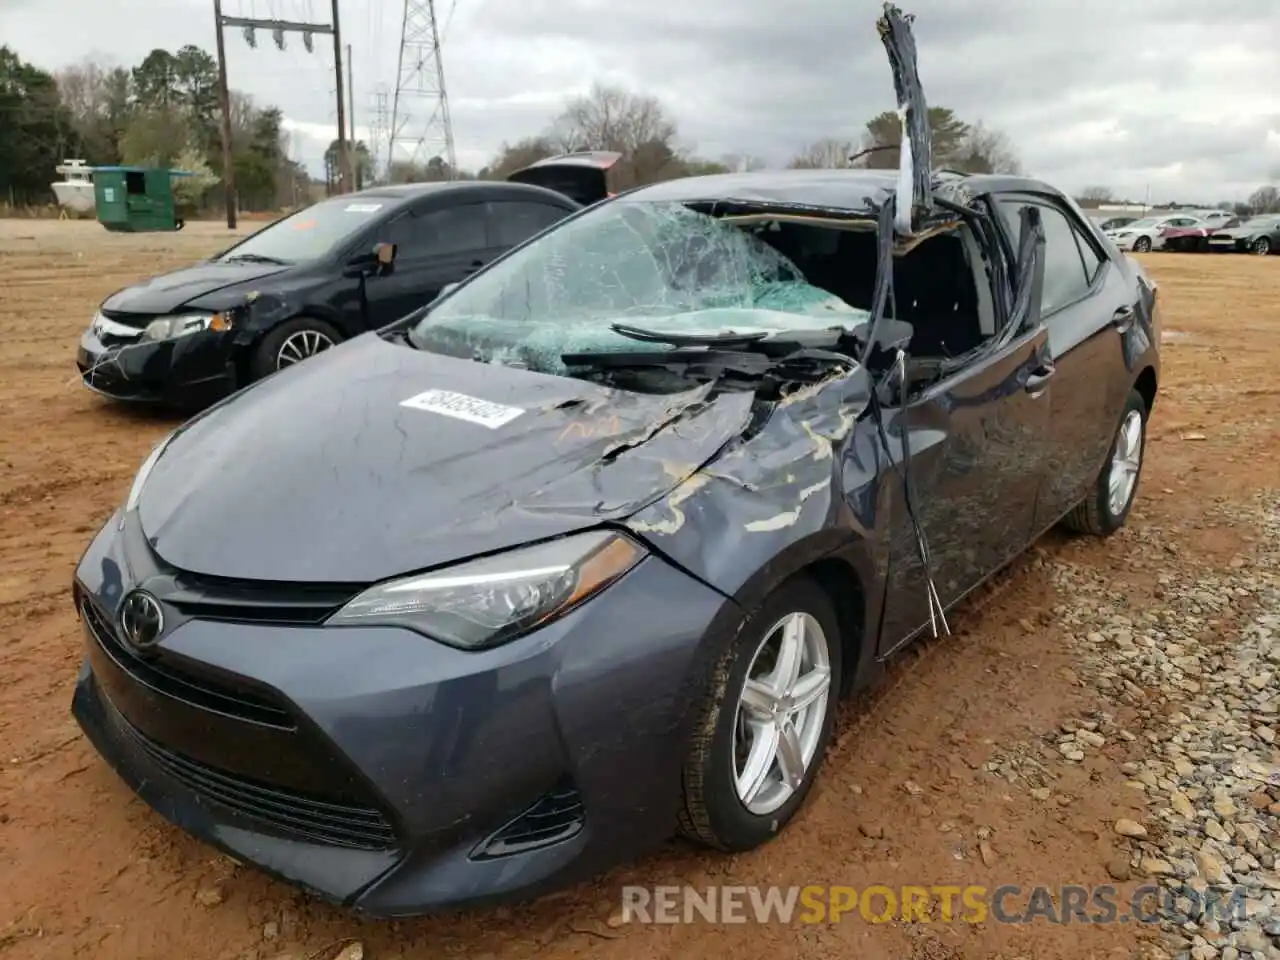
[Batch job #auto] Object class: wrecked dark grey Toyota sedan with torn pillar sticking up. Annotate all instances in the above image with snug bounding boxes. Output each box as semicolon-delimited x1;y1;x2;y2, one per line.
73;9;1160;915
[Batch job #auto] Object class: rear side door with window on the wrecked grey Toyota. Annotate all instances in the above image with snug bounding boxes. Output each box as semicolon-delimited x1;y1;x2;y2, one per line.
996;193;1138;534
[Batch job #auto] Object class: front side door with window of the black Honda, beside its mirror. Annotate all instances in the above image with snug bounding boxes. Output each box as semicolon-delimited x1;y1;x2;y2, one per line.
365;201;498;326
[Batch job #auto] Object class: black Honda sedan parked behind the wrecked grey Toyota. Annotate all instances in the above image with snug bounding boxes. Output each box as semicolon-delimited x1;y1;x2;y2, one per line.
76;154;618;410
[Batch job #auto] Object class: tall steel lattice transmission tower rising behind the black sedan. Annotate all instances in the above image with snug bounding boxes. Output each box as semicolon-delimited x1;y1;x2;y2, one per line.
387;0;458;179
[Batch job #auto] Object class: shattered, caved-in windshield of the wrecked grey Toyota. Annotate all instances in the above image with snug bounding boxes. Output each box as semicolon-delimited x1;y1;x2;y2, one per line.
410;200;869;374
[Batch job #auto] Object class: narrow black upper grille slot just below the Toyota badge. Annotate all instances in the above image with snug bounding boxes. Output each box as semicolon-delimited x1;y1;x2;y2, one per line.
79;599;296;730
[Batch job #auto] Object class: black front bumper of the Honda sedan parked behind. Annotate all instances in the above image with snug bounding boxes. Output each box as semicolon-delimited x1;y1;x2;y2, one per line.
76;328;237;408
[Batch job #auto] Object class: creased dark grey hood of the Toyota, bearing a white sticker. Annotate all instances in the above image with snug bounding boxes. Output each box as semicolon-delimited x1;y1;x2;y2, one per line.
138;334;754;584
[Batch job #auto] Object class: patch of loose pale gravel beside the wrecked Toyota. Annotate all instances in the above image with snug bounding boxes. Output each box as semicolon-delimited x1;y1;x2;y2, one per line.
987;495;1280;960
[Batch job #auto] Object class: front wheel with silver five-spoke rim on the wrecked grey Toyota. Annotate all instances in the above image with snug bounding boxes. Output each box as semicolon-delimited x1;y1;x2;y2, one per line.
680;577;841;851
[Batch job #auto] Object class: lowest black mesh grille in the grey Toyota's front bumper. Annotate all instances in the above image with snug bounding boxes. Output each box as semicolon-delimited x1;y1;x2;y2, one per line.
111;712;396;850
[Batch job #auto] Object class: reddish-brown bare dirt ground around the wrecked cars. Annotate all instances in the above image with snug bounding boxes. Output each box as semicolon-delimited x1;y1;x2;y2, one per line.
0;220;1280;960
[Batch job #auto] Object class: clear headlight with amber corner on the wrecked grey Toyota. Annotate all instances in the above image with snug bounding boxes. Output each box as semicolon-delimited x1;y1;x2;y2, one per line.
326;530;645;650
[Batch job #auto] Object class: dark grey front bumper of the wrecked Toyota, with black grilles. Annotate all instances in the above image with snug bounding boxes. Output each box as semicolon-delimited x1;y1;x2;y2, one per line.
73;517;727;916
